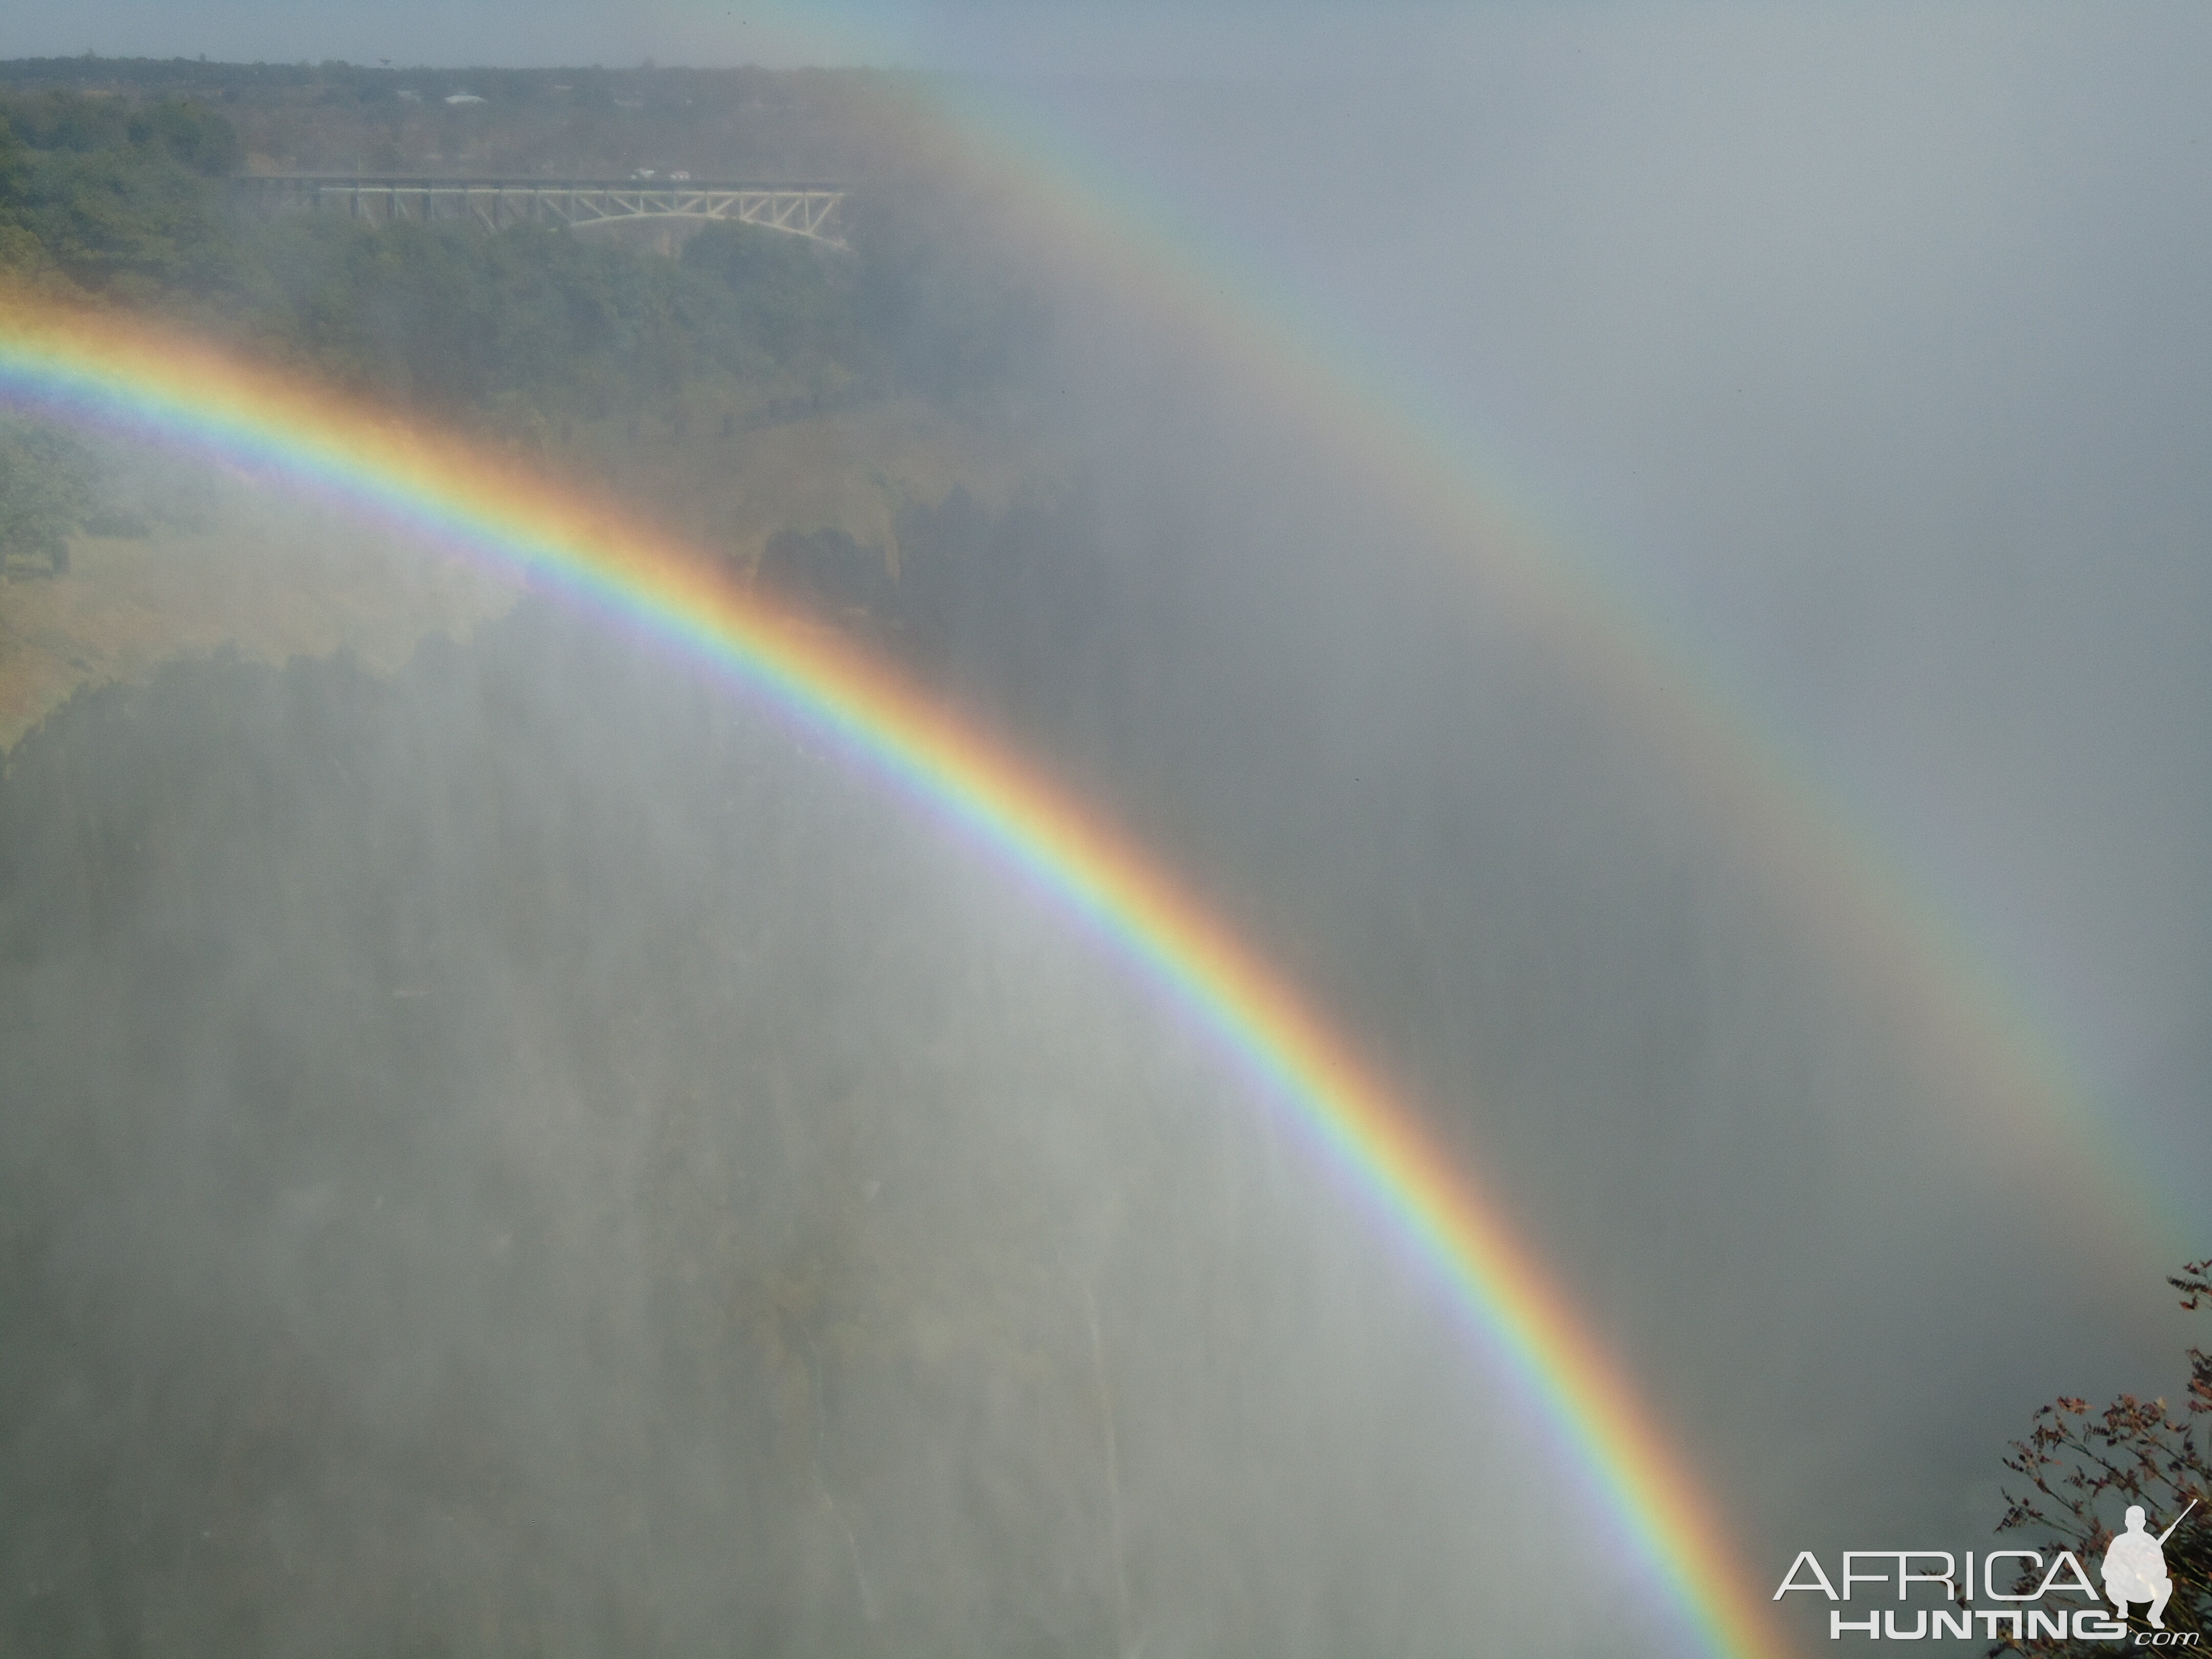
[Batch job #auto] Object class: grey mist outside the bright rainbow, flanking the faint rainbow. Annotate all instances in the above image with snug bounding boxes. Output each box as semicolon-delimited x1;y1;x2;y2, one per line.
977;9;2212;1579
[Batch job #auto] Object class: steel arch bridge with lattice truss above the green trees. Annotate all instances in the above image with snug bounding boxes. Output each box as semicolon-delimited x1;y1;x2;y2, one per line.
235;173;845;248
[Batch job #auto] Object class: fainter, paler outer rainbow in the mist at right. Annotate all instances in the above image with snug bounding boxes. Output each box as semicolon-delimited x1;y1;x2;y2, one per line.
933;95;2176;1277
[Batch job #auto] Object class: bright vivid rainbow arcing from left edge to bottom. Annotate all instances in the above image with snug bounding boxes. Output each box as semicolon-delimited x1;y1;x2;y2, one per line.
0;299;1788;1659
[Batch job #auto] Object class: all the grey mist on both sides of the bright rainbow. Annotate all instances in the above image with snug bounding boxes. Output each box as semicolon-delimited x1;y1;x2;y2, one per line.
0;7;2212;1659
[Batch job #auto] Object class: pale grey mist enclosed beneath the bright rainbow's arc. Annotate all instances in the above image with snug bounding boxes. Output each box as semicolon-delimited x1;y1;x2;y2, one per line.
0;606;1592;1654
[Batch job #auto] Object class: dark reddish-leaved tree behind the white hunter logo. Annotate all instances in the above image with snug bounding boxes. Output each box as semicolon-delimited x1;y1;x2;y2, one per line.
1991;1259;2212;1659
